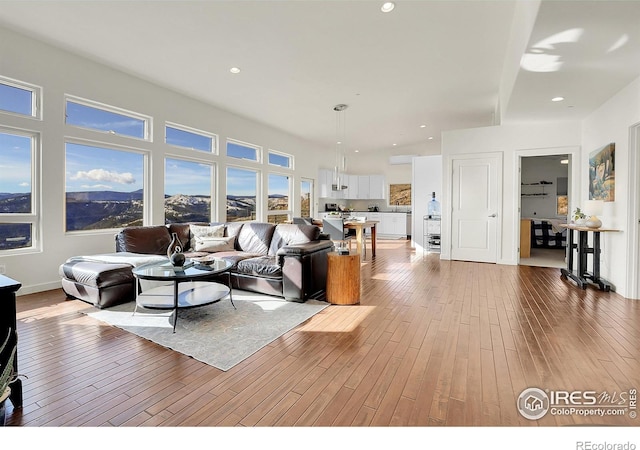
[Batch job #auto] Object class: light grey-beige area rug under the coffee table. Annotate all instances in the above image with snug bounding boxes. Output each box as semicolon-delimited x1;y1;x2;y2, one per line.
84;290;329;371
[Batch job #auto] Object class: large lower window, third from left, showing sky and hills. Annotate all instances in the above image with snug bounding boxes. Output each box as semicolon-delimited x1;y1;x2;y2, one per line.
164;158;213;223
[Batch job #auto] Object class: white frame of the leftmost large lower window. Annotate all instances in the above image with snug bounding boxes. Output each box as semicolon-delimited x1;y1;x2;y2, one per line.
0;125;42;256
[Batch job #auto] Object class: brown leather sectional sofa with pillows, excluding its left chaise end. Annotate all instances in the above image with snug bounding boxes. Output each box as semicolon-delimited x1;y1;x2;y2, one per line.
116;222;333;302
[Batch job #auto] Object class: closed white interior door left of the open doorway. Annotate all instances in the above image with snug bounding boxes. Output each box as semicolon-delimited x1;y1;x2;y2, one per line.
451;156;500;263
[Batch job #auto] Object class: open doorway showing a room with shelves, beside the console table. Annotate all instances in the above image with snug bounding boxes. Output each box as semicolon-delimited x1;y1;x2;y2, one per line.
519;154;571;268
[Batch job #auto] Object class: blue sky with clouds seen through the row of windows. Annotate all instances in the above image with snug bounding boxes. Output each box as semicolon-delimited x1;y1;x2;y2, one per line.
0;84;289;196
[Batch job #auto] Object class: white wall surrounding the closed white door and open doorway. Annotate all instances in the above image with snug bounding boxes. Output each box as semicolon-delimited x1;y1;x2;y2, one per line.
441;122;581;264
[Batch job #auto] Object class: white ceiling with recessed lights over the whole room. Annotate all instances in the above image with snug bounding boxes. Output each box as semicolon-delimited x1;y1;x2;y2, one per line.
0;0;640;154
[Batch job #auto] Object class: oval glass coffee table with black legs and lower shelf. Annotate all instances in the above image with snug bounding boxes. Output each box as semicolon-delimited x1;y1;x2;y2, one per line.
132;259;236;333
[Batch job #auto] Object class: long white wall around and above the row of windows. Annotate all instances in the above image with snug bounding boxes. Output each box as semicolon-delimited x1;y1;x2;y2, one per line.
0;28;324;294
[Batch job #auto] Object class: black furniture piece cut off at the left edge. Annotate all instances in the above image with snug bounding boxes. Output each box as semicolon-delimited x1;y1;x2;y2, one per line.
0;275;22;408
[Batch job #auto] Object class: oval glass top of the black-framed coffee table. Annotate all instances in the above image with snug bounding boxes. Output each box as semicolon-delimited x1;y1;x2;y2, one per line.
132;259;233;280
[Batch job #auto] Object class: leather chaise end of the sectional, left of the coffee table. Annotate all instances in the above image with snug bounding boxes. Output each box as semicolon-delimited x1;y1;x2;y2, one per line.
60;260;135;308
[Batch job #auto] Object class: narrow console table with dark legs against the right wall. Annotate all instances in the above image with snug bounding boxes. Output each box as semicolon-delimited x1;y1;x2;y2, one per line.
560;224;620;291
